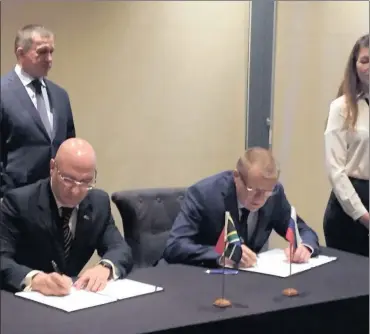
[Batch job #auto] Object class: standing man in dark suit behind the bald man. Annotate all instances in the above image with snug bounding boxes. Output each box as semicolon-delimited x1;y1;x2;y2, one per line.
0;25;75;198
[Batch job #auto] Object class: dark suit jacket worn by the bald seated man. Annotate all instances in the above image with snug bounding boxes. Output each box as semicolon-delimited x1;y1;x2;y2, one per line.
0;180;133;290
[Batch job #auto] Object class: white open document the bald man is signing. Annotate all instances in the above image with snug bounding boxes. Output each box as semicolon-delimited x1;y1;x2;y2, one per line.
15;279;163;312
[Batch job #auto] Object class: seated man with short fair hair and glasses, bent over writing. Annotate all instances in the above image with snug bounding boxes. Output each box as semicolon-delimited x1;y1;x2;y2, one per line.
164;148;319;267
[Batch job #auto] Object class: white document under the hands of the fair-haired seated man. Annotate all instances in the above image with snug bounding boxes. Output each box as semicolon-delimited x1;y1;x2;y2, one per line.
239;249;337;277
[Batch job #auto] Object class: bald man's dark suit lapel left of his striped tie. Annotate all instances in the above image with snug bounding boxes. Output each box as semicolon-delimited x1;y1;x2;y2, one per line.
37;180;65;268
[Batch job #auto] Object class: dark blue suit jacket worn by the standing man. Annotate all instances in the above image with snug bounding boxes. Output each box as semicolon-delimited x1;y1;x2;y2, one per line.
0;71;75;198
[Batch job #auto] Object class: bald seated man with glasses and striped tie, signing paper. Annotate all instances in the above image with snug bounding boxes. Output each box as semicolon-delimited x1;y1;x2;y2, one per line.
0;138;133;295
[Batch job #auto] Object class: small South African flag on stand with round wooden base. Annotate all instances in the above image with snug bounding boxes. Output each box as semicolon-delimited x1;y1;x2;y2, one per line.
213;211;243;307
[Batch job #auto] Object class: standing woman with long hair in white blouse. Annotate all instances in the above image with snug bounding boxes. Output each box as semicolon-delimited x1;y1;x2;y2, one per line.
324;35;369;256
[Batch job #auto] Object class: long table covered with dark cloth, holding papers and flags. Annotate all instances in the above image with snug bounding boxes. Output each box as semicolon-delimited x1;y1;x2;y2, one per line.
1;248;369;334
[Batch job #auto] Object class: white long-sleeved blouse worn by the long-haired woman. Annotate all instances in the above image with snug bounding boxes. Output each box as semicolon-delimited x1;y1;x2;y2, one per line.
325;96;369;220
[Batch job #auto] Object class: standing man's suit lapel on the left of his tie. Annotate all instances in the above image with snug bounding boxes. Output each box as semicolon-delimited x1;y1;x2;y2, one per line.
9;72;49;139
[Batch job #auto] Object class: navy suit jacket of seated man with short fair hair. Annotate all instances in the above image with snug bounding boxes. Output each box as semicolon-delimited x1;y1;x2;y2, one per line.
164;171;319;267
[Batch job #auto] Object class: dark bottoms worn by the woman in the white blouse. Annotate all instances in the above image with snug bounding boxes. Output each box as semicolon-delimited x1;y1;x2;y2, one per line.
324;178;369;256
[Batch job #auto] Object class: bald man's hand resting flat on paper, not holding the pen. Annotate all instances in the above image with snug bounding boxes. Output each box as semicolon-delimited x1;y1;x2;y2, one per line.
74;264;110;292
